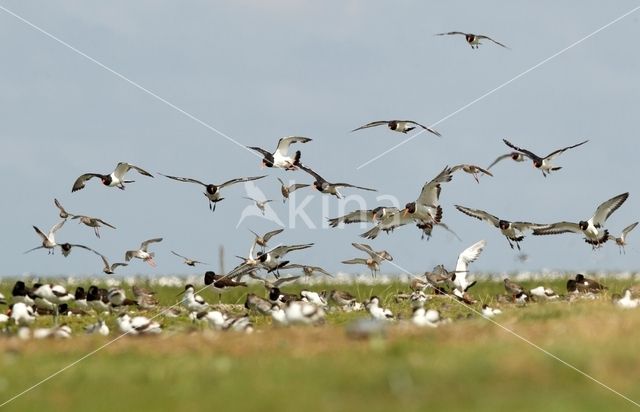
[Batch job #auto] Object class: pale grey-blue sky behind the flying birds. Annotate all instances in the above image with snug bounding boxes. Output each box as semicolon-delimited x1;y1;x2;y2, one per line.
0;0;640;276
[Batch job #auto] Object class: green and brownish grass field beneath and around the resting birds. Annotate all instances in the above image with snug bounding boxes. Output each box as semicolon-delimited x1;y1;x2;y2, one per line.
0;280;640;411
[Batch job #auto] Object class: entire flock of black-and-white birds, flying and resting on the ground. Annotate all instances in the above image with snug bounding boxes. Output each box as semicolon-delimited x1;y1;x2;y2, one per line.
0;32;640;338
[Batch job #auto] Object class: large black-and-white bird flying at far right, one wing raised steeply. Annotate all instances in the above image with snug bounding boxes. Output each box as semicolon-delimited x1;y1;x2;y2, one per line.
533;192;629;249
